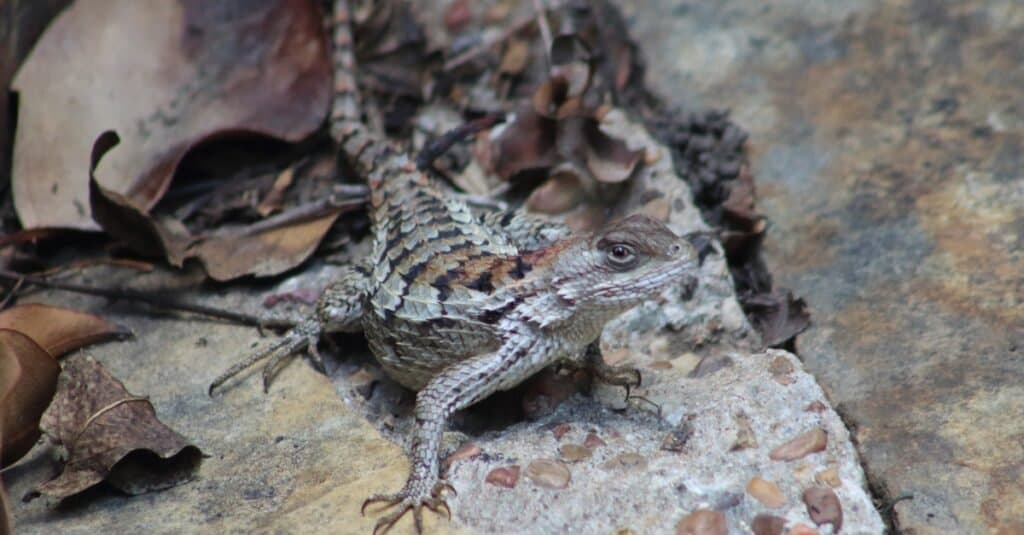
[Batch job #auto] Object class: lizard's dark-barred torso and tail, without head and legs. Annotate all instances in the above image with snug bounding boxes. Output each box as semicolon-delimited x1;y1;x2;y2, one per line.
331;3;528;389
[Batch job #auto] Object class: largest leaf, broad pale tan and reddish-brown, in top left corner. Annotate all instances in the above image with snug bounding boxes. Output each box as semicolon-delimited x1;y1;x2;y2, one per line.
12;0;330;230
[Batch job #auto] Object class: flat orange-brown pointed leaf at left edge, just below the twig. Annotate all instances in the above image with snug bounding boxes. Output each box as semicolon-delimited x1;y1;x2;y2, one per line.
0;303;130;357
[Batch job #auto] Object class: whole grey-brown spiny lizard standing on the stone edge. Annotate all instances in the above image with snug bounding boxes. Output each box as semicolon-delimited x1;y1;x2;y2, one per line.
210;0;698;534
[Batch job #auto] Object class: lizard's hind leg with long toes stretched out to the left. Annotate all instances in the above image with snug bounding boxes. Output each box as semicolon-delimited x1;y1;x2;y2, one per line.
209;265;367;395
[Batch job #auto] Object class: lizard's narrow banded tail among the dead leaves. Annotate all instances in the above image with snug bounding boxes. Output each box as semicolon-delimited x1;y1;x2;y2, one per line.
331;0;393;179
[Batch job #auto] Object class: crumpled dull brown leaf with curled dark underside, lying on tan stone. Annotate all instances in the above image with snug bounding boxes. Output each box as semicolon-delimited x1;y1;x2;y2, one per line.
37;357;203;498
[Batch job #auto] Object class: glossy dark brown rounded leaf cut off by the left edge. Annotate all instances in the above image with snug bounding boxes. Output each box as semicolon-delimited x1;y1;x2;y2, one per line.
0;329;60;467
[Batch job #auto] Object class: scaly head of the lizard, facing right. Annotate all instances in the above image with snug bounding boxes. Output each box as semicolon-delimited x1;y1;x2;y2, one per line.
559;215;698;313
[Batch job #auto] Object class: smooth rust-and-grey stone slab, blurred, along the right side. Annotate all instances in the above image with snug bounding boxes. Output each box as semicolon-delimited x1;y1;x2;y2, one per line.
624;0;1024;533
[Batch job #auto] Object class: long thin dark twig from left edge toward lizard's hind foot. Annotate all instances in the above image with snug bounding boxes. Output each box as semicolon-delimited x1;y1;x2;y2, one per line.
0;270;295;329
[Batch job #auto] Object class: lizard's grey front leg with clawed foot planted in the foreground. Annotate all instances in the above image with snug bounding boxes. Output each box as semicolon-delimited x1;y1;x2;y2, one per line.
362;333;556;533
